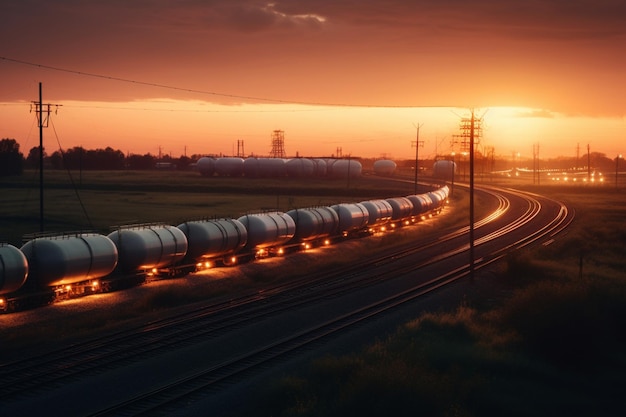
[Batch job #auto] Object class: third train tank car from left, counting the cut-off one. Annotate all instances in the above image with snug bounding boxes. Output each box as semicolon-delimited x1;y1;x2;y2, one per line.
109;225;188;271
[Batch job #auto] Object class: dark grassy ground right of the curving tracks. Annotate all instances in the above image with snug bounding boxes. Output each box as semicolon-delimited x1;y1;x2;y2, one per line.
244;188;626;416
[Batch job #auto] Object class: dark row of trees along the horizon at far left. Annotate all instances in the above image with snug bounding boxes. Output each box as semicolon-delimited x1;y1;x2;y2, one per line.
0;138;200;176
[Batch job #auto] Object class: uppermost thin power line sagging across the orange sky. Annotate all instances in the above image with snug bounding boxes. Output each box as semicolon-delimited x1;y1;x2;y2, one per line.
0;56;458;108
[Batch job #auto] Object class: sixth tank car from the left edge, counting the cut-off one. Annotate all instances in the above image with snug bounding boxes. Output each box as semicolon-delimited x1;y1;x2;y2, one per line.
286;207;339;241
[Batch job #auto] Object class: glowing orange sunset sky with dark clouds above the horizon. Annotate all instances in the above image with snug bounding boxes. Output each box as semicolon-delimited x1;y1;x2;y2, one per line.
0;0;626;159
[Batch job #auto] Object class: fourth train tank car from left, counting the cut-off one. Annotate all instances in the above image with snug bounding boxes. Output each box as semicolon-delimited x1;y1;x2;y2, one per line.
177;219;248;259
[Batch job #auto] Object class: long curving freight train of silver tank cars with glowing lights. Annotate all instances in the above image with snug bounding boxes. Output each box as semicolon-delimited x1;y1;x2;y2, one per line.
0;186;449;312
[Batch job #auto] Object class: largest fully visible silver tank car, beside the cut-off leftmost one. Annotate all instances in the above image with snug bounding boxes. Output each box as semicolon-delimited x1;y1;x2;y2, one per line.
21;233;118;286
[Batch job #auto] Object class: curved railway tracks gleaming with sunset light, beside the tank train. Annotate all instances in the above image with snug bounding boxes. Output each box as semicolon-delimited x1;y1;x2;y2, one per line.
0;187;573;415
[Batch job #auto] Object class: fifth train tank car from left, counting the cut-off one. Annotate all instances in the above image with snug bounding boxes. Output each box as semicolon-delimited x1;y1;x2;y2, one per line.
237;211;296;249
